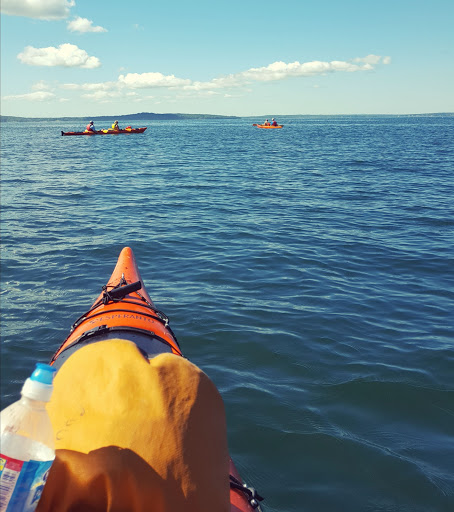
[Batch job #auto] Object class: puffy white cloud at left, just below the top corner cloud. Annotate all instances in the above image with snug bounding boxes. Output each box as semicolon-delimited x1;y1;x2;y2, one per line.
17;43;101;69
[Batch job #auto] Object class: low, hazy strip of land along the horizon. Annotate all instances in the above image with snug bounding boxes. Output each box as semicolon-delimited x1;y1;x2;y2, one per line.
0;112;454;122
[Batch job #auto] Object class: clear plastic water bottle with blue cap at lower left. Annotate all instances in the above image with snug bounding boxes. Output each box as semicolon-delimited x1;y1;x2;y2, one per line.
0;363;55;512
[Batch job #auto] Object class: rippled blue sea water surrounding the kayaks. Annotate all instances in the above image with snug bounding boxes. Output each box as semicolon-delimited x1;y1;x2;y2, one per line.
1;116;454;512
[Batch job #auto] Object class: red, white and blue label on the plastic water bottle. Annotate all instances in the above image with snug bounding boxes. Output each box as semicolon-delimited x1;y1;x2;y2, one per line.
0;454;53;512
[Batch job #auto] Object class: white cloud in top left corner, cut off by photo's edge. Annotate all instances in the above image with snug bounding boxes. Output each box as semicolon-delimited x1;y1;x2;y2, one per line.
1;0;75;20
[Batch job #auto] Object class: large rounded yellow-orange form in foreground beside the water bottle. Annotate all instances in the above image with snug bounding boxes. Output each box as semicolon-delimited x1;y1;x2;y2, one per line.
36;339;230;512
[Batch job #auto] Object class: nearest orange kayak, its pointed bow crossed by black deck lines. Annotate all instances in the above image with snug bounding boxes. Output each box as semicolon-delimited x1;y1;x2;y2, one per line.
50;247;263;512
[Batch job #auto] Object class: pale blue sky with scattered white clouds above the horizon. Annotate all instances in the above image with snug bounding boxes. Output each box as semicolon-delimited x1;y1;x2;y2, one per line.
1;0;454;117
